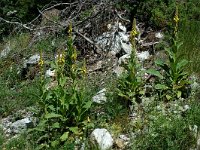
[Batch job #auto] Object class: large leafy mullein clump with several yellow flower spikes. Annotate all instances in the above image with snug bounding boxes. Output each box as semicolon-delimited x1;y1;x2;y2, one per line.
31;22;93;148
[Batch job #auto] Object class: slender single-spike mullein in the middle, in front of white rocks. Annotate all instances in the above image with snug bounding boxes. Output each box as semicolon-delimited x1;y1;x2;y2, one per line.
118;19;144;106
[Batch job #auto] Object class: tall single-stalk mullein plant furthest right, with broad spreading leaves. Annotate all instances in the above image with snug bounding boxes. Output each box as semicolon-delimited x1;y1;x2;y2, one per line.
147;8;190;101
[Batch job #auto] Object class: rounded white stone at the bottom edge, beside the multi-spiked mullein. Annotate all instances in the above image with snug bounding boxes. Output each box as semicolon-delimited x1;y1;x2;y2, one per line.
91;129;113;150
